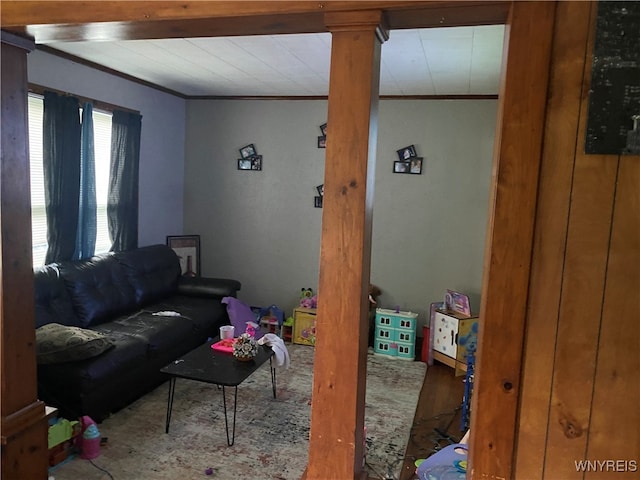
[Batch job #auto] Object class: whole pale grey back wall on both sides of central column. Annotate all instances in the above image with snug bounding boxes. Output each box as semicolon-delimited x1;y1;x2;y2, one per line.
184;100;497;322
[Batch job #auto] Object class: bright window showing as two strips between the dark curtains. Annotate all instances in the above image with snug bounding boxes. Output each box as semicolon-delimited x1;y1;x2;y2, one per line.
28;94;111;266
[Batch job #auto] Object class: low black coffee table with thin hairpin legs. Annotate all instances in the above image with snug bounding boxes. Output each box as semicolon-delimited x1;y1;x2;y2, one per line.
160;338;276;446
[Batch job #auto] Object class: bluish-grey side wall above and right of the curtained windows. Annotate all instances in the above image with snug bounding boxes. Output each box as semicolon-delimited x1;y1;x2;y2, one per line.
28;50;185;246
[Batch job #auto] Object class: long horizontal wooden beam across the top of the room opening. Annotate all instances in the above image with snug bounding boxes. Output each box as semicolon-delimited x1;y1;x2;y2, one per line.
0;0;509;43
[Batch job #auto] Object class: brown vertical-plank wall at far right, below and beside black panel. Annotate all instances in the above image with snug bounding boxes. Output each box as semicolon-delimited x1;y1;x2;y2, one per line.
513;2;640;480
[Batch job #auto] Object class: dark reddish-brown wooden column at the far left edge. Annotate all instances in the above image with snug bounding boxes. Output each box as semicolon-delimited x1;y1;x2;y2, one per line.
0;32;48;480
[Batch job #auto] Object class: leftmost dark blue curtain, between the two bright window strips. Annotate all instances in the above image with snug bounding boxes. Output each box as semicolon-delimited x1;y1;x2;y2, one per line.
42;92;80;263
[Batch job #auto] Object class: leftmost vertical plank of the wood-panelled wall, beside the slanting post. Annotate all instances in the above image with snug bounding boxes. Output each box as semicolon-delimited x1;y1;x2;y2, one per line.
515;2;590;478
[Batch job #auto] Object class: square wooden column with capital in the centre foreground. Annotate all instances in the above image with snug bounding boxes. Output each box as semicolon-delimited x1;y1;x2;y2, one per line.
305;11;388;480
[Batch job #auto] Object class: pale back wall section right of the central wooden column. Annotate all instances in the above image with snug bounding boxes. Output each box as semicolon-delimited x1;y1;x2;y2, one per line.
371;100;497;319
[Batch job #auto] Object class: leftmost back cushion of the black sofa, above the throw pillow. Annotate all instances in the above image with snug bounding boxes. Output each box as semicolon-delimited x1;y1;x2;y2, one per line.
33;264;82;328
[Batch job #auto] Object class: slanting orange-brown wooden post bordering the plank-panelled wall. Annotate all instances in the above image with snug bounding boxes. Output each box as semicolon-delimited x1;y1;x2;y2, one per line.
469;1;556;479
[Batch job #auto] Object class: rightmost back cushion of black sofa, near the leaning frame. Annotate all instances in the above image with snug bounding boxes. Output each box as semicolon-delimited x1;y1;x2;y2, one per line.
114;245;180;306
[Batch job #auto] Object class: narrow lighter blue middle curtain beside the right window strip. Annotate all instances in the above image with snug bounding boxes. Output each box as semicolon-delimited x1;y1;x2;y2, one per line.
73;103;98;260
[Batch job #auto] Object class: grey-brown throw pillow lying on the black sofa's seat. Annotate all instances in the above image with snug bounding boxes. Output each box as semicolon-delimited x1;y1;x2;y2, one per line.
36;323;114;364
